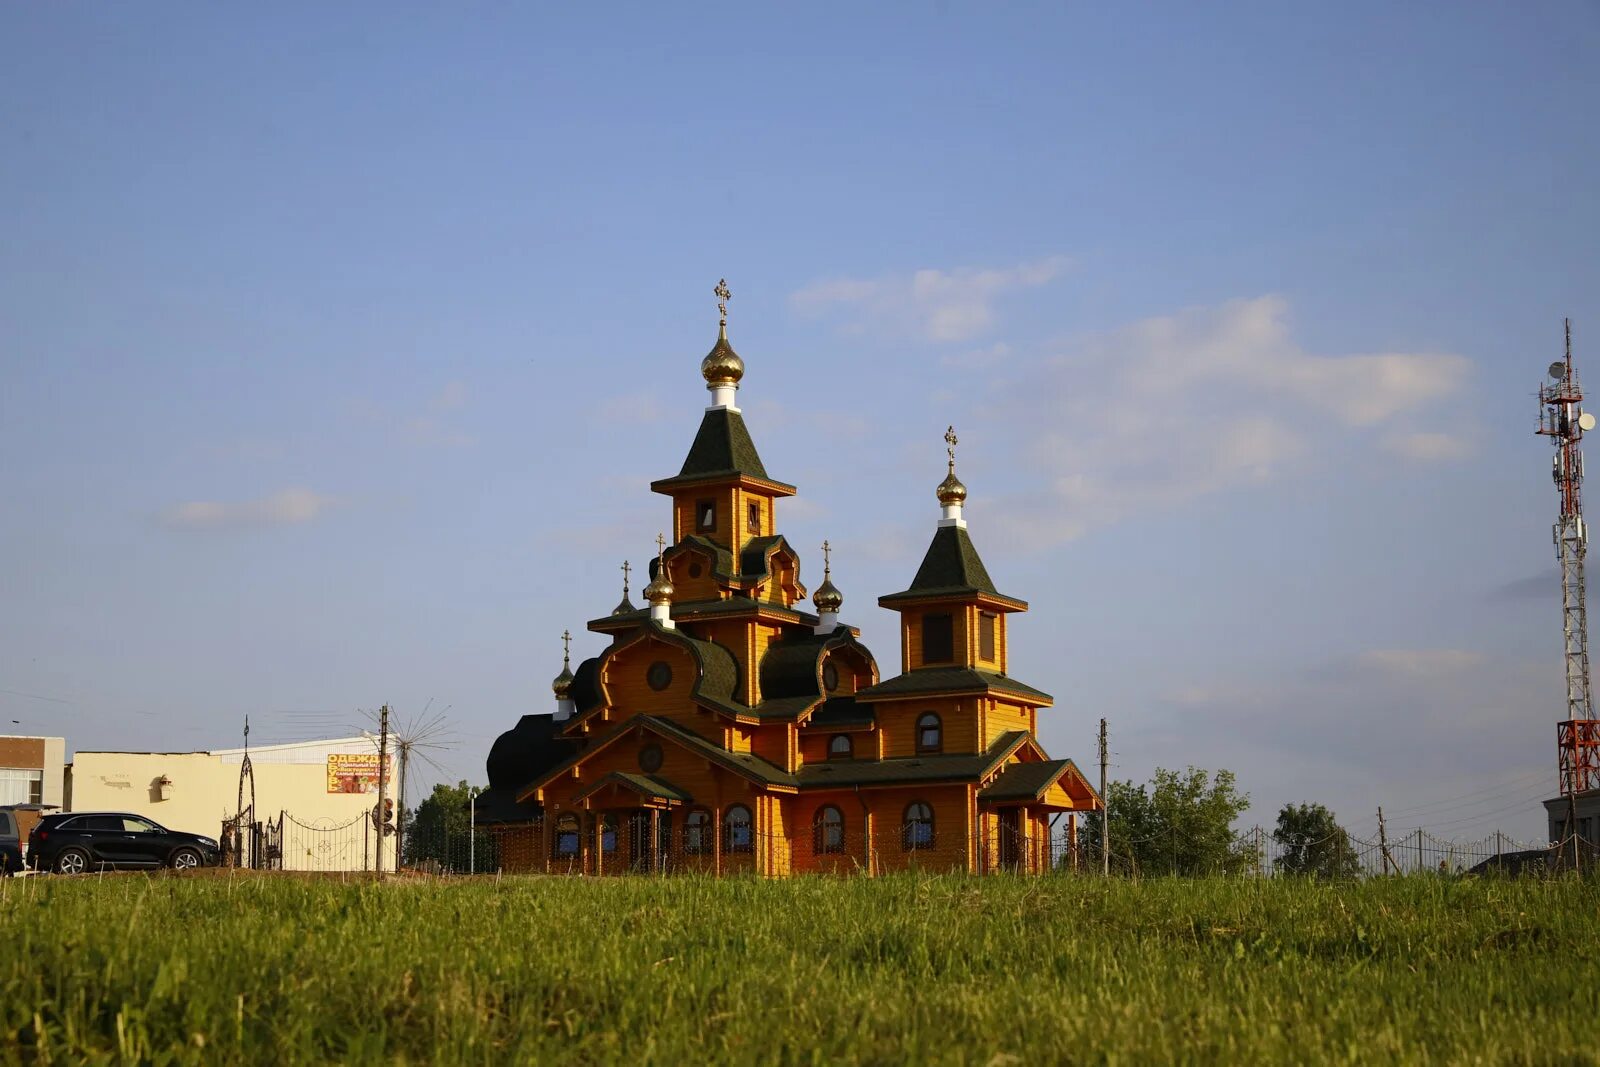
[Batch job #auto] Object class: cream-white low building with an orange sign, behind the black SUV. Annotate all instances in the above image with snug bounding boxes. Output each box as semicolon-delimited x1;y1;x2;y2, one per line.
67;737;395;870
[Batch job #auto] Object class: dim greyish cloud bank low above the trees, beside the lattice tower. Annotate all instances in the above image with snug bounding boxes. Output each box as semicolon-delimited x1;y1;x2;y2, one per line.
1142;648;1560;838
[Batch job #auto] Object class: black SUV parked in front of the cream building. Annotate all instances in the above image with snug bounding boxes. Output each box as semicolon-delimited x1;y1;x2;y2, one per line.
27;811;221;875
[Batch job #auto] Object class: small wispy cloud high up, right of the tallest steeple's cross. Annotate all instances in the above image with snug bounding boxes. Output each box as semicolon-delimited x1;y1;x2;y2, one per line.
789;256;1067;344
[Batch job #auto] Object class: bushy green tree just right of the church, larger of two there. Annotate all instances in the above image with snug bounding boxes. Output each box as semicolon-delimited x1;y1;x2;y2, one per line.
1082;766;1258;877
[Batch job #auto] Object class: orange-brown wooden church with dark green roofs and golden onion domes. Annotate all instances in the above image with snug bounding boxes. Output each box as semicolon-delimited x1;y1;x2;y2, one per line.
478;283;1101;875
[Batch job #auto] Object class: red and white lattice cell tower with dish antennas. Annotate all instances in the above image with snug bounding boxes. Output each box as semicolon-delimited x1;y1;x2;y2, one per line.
1539;318;1600;797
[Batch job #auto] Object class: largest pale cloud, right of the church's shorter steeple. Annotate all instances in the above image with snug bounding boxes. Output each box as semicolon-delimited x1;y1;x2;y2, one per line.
978;296;1470;547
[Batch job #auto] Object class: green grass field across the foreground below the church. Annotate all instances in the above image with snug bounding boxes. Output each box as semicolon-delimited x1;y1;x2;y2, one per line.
0;873;1600;1064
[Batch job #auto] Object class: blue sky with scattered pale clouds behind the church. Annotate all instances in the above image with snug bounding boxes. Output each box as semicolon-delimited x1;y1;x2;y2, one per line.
0;3;1600;837
